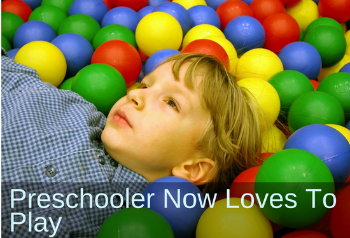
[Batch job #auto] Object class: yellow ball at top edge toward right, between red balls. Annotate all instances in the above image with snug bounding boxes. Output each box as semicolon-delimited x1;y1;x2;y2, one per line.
286;0;320;32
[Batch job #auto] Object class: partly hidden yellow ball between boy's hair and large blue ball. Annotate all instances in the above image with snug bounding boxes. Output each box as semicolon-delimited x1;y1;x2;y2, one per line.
261;125;287;153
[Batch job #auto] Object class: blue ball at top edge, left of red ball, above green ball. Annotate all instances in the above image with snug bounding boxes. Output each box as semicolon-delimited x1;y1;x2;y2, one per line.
68;0;108;24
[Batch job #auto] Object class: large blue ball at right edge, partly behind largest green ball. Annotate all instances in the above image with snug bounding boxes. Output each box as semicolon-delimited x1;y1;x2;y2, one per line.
283;124;350;187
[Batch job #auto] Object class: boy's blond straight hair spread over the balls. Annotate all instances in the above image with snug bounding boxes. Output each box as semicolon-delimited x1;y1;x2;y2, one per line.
161;53;261;193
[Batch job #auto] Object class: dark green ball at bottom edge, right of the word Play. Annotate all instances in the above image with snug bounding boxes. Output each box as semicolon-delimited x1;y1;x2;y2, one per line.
97;207;174;238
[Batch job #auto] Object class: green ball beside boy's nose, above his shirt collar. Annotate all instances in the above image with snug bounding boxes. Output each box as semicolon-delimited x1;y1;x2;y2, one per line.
71;64;127;116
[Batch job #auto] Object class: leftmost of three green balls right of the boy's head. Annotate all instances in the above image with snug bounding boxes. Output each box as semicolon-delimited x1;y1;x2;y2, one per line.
269;70;314;121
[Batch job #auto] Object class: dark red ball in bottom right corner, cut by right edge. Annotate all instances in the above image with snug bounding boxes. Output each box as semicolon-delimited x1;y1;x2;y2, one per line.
330;185;350;238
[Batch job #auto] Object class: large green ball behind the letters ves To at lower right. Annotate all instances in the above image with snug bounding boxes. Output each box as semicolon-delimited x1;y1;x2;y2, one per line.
255;149;334;228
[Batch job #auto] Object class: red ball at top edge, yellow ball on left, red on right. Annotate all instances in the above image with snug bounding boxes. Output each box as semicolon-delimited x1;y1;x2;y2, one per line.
216;0;253;31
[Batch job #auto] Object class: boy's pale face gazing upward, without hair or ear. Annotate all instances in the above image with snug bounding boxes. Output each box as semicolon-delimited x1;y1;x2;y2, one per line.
102;62;210;181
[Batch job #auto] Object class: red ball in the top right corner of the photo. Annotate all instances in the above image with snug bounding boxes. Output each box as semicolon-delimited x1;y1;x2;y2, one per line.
318;0;350;23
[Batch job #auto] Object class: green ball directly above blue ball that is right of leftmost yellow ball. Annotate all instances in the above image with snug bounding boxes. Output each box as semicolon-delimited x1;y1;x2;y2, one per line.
58;14;101;44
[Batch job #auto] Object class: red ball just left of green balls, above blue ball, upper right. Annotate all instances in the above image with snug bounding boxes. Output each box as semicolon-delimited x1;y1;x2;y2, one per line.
262;13;300;54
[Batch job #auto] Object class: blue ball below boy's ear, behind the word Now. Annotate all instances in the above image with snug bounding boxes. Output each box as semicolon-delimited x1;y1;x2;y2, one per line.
140;176;206;238
